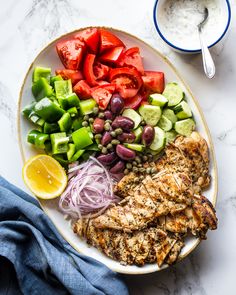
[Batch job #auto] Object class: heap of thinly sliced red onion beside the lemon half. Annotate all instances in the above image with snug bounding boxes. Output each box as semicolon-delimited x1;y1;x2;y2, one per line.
59;156;120;218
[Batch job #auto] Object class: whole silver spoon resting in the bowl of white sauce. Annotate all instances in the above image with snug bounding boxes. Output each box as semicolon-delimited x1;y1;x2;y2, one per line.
198;7;216;79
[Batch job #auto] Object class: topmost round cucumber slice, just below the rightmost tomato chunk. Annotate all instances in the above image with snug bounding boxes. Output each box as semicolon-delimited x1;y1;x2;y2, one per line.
162;82;184;107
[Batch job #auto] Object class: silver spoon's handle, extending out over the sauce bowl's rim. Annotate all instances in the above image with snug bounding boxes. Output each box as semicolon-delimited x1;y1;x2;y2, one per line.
199;30;216;79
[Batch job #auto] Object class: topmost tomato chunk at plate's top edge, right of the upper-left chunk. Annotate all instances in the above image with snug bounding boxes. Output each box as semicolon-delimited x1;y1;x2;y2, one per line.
75;28;100;54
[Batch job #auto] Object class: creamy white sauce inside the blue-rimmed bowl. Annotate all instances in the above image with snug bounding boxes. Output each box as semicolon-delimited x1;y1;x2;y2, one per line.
157;0;228;50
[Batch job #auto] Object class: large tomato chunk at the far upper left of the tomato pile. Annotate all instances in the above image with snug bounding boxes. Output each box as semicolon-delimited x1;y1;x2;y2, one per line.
56;39;85;70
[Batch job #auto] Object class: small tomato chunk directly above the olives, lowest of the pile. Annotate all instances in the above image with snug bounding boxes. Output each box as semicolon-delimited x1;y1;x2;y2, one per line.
91;83;115;110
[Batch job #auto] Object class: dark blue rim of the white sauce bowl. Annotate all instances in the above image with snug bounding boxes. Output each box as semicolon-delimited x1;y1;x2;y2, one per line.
153;0;231;53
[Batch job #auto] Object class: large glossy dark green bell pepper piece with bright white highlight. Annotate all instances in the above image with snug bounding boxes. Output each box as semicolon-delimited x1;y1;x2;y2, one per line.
34;97;65;123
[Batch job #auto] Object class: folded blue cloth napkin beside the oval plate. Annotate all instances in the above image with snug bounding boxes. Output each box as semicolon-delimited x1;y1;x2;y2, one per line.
0;177;128;295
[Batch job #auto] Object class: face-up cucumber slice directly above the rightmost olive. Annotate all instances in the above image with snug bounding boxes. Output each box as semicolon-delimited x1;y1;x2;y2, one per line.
139;105;161;126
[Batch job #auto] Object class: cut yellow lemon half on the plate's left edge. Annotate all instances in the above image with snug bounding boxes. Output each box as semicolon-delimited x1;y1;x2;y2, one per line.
23;154;67;200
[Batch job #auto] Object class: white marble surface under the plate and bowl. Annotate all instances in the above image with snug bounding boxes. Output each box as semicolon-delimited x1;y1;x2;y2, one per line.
0;0;236;295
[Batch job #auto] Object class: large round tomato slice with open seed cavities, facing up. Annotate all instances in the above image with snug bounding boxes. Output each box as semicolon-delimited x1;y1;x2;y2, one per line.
109;67;143;99
